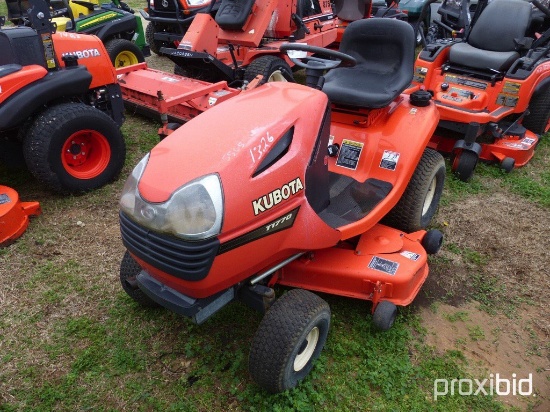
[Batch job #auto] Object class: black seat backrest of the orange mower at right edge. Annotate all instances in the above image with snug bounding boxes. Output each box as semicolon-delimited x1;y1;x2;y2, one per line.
467;0;531;52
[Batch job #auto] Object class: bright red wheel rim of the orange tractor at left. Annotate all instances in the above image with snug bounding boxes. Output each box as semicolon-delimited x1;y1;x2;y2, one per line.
61;130;111;179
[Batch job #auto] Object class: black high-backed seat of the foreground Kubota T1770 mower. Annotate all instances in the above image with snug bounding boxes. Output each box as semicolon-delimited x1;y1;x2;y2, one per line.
323;18;415;108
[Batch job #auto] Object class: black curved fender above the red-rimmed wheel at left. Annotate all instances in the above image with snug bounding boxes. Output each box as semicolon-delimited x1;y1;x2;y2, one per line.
0;66;92;130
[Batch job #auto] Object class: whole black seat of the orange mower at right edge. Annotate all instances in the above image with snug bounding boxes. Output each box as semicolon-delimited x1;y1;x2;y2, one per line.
449;0;531;72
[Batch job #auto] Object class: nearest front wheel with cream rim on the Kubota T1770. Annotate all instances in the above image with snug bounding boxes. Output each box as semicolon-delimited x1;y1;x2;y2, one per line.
249;289;330;393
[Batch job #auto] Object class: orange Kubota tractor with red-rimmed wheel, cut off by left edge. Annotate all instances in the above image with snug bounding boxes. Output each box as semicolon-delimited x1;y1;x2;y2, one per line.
0;1;126;192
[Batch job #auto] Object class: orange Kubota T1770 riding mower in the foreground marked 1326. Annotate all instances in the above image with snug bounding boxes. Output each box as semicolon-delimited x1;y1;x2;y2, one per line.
120;19;445;392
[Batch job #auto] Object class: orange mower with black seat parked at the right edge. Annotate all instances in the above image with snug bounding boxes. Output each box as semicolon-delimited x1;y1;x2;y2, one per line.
414;0;550;180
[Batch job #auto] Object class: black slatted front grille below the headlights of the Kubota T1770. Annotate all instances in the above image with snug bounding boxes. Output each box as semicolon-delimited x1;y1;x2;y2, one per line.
120;212;220;281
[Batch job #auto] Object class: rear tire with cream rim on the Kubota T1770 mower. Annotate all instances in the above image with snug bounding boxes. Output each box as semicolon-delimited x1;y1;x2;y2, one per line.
383;149;445;233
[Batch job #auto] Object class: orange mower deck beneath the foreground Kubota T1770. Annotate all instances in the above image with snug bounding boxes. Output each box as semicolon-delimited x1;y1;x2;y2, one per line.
269;224;429;311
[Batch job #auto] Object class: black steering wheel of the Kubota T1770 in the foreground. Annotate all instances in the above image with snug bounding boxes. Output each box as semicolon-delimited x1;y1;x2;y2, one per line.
280;43;357;70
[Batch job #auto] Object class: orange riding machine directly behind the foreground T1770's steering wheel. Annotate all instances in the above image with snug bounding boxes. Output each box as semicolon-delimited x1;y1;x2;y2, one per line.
161;0;350;82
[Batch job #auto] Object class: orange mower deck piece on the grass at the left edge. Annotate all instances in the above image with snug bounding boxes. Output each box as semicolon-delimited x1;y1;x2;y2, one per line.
0;185;40;247
